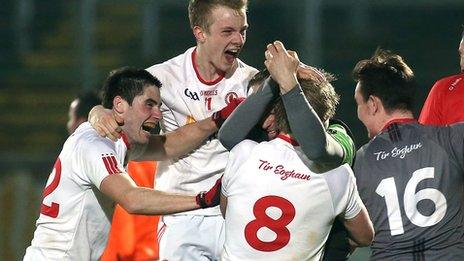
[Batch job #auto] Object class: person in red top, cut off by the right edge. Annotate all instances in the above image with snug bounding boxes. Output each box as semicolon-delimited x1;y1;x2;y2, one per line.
419;26;464;125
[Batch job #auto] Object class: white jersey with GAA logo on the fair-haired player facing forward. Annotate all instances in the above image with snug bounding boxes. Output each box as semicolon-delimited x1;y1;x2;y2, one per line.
147;47;257;215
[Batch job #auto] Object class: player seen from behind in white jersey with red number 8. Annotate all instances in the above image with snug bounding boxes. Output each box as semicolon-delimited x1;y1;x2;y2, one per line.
221;42;374;260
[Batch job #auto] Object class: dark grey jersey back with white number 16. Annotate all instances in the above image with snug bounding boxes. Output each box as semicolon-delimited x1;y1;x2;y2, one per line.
354;122;464;260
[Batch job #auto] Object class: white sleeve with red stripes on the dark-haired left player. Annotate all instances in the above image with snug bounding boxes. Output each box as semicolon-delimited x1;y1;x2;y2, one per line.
73;139;124;189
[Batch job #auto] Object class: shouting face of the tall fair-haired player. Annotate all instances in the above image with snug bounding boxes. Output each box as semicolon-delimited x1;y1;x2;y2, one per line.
194;6;248;76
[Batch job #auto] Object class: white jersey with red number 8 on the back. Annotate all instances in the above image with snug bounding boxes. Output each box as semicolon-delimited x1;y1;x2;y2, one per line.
222;136;363;260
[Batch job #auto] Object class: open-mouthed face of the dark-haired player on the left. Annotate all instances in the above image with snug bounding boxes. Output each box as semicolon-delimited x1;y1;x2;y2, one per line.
121;85;162;144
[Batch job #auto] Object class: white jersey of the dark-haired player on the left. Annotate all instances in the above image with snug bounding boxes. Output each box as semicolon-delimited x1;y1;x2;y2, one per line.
24;122;127;261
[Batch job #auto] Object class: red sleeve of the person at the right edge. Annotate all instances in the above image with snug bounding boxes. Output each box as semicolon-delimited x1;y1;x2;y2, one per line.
418;81;444;125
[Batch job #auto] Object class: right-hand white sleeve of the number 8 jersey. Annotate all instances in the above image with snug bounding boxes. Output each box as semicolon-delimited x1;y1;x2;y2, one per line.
326;164;363;219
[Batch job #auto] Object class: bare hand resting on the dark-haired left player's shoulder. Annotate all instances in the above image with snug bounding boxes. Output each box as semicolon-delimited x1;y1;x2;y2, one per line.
89;105;124;141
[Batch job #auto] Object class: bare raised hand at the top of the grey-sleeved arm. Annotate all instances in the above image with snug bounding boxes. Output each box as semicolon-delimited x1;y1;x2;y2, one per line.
264;41;300;93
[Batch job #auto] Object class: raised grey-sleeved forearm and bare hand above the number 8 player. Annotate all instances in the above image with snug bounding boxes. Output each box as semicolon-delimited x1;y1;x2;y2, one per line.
265;41;354;172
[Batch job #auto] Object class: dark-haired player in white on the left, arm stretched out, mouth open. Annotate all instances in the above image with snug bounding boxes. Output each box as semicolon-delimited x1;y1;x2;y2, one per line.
24;68;220;260
